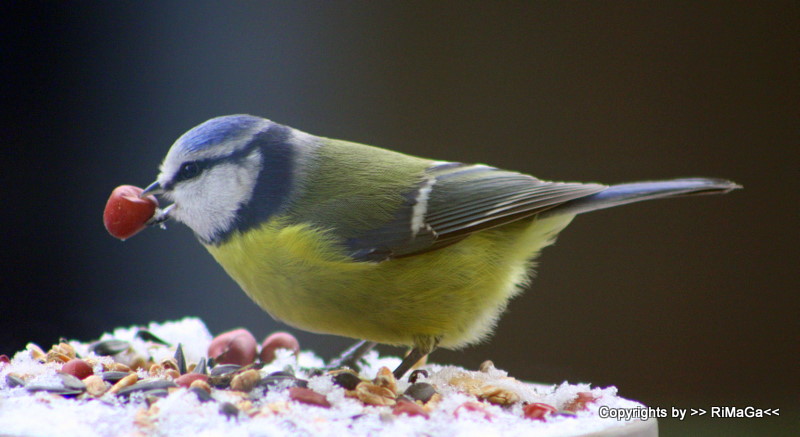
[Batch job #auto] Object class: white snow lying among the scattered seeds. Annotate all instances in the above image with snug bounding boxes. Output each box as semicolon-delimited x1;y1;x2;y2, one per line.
0;318;656;437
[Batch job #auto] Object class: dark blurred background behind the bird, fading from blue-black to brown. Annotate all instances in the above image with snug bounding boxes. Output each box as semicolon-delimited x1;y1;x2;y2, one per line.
0;1;800;436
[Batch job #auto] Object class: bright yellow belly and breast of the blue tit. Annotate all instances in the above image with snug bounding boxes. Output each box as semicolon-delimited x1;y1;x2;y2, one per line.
206;217;572;348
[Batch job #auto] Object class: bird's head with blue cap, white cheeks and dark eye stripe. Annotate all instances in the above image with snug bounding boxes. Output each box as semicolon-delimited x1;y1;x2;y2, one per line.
142;115;302;243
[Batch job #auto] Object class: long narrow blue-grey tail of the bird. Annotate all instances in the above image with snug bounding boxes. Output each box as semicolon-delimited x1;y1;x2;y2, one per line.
541;178;742;216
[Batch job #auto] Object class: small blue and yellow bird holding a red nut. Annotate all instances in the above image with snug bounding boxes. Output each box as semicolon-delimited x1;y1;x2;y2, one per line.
141;114;740;379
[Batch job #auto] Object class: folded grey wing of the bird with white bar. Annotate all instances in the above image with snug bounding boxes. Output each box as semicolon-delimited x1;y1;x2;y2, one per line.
346;162;607;261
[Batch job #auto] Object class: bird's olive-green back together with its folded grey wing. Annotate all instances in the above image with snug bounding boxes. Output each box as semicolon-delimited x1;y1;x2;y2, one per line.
286;139;605;262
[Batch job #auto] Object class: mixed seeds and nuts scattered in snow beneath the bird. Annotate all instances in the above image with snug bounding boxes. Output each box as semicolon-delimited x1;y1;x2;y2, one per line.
0;318;643;437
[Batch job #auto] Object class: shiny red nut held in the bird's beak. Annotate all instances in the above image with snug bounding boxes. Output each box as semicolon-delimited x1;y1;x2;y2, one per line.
103;185;158;240
